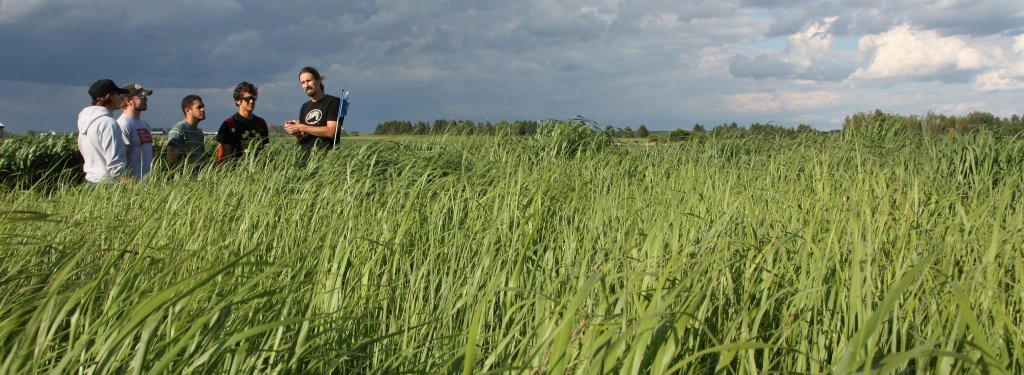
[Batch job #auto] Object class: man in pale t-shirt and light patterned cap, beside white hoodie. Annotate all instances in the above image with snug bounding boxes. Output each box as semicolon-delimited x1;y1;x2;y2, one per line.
118;83;153;179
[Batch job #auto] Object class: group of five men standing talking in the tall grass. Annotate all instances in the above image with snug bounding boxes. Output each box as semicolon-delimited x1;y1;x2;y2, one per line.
78;67;341;186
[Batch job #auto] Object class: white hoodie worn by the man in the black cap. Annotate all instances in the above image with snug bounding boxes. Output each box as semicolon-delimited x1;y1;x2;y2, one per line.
78;106;130;183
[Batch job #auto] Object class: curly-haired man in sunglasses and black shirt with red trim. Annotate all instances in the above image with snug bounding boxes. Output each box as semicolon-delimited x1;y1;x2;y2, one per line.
215;82;270;164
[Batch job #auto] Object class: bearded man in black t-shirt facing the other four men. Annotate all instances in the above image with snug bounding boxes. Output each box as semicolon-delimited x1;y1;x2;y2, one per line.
285;67;341;151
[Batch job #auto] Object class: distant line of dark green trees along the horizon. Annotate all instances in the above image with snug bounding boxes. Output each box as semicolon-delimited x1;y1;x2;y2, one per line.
374;110;1024;140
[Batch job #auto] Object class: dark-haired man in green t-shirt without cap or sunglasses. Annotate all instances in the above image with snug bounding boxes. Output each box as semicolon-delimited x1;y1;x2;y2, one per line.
167;95;206;174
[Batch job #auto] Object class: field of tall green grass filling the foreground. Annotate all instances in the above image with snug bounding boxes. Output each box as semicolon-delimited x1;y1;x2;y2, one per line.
0;117;1024;374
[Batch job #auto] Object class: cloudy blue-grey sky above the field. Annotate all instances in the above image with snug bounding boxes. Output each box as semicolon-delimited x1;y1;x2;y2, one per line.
0;0;1024;133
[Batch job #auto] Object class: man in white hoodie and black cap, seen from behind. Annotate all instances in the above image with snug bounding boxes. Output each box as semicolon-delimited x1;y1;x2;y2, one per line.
78;79;133;185
